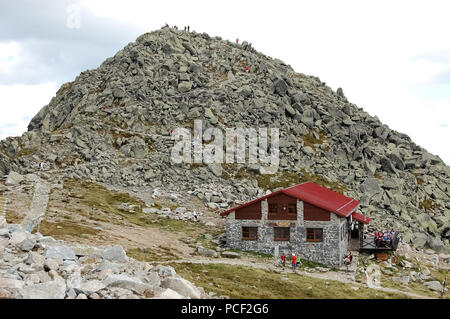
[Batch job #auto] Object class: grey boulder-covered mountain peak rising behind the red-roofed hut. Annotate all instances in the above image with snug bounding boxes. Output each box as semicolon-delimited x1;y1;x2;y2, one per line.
0;27;450;251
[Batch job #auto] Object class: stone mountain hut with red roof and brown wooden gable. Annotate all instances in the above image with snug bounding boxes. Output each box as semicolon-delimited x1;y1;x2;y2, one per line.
221;182;370;266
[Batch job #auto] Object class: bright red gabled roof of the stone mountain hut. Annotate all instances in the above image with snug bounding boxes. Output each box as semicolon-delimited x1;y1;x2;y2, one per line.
220;182;359;217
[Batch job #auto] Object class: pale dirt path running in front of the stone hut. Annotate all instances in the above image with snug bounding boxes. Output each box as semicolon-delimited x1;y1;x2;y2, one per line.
157;258;432;299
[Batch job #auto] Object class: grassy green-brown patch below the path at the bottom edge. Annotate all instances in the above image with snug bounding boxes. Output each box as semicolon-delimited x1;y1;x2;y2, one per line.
171;263;405;299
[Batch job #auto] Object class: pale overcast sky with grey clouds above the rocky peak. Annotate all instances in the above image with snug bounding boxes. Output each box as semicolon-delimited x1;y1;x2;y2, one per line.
0;0;450;164
